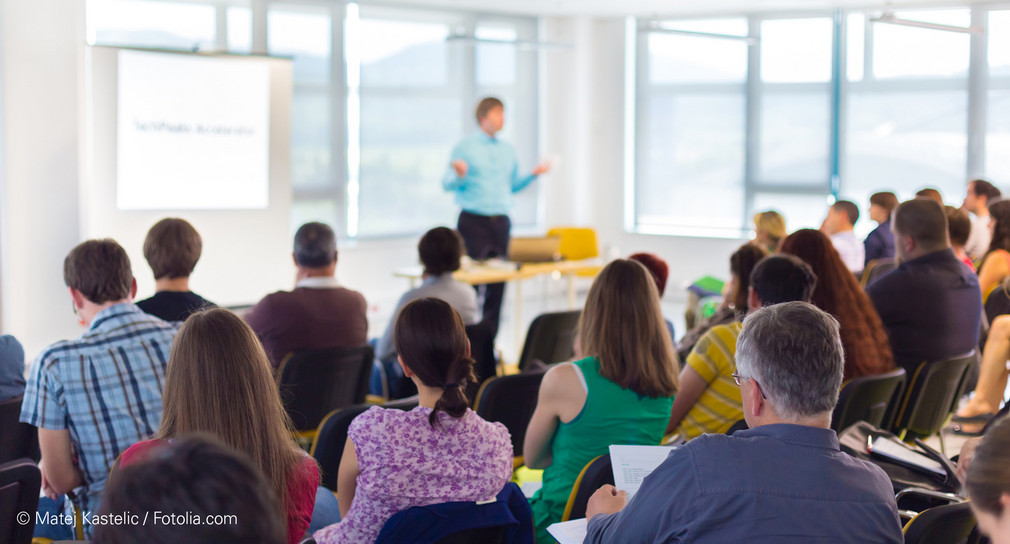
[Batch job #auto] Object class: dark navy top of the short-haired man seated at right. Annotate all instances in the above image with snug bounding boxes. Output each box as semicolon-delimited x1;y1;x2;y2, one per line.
867;248;982;378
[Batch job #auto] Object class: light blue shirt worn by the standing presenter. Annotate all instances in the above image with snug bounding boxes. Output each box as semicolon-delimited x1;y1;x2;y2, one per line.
442;131;536;215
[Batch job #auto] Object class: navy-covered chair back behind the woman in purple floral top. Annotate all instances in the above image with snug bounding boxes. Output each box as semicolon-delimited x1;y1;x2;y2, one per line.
376;481;533;544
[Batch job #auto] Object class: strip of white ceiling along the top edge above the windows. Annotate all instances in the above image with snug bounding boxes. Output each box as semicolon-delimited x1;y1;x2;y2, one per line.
359;0;997;17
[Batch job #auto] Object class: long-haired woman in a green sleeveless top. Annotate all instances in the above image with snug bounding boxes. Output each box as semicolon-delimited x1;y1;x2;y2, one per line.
523;259;678;542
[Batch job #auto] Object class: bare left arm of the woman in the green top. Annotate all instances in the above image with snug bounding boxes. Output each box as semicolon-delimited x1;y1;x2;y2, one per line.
522;364;586;468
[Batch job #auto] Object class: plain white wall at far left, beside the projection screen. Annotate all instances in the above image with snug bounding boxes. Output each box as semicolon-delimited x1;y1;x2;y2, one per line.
0;0;85;357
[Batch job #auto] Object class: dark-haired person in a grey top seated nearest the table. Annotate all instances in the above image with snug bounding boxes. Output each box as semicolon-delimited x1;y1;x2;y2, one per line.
373;227;480;398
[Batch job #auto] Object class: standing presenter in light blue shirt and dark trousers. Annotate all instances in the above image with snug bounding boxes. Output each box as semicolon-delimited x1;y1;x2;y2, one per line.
442;97;549;336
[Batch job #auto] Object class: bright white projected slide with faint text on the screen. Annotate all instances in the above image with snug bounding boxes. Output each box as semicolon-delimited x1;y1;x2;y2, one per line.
116;49;270;210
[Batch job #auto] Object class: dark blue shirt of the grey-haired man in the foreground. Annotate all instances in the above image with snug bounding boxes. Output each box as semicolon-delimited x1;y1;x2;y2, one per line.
585;424;904;544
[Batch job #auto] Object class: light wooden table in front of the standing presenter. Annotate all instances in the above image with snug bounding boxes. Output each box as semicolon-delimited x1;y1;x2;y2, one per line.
393;258;601;352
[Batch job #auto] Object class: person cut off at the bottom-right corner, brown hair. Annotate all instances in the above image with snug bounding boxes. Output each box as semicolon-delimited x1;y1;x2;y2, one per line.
963;418;1010;544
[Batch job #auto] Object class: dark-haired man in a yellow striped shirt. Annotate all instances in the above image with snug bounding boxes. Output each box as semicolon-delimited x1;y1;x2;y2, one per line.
667;253;817;440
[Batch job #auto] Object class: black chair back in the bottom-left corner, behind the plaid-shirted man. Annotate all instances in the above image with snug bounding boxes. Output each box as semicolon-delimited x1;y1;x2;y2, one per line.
0;459;42;544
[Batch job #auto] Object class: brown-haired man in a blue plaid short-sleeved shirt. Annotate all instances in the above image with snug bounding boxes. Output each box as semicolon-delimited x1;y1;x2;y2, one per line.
20;239;176;540
